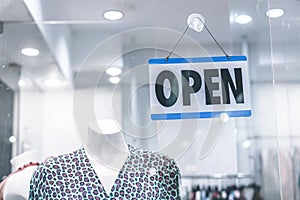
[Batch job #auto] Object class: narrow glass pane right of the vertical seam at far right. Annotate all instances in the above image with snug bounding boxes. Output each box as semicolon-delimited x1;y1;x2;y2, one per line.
269;0;300;199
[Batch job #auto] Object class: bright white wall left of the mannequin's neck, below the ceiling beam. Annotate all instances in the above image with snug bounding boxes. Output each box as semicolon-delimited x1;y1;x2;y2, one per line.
19;88;79;159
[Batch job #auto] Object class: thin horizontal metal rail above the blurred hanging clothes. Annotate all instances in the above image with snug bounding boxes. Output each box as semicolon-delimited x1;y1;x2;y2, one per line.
181;173;253;179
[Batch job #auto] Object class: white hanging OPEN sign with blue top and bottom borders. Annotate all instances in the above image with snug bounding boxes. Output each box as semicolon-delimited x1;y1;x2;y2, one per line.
148;56;251;120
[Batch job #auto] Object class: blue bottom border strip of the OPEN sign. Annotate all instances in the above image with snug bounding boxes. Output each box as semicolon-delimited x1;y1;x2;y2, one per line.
151;110;251;120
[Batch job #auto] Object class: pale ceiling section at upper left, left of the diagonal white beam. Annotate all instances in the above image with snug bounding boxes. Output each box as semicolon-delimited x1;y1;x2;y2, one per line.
0;0;63;90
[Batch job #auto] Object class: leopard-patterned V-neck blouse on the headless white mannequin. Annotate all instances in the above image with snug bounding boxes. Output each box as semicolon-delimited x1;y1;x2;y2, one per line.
29;145;180;200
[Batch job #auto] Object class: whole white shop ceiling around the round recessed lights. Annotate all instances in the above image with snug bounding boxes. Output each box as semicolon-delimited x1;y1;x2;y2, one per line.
0;0;300;89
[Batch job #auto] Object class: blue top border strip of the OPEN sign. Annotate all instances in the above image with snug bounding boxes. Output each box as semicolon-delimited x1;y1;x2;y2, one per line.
148;56;247;64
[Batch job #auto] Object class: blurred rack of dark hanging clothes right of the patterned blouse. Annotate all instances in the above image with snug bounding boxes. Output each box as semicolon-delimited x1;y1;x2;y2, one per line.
181;173;261;200
